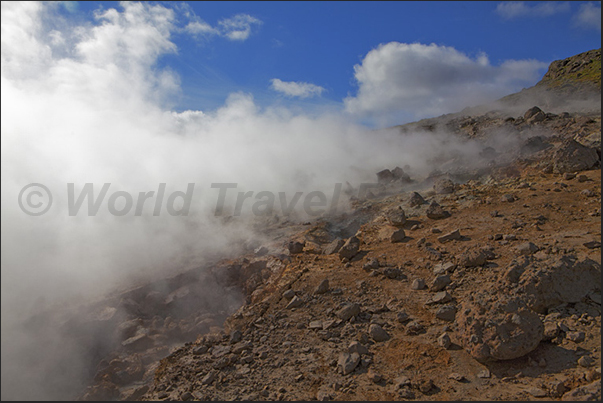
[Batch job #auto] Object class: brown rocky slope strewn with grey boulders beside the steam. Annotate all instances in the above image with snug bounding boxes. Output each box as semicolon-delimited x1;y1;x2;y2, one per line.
72;50;601;400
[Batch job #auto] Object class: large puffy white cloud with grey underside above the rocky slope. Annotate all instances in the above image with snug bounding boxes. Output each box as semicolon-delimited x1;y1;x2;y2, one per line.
344;42;547;123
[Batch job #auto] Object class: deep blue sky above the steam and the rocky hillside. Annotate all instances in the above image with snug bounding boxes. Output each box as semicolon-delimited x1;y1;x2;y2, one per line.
55;2;601;123
